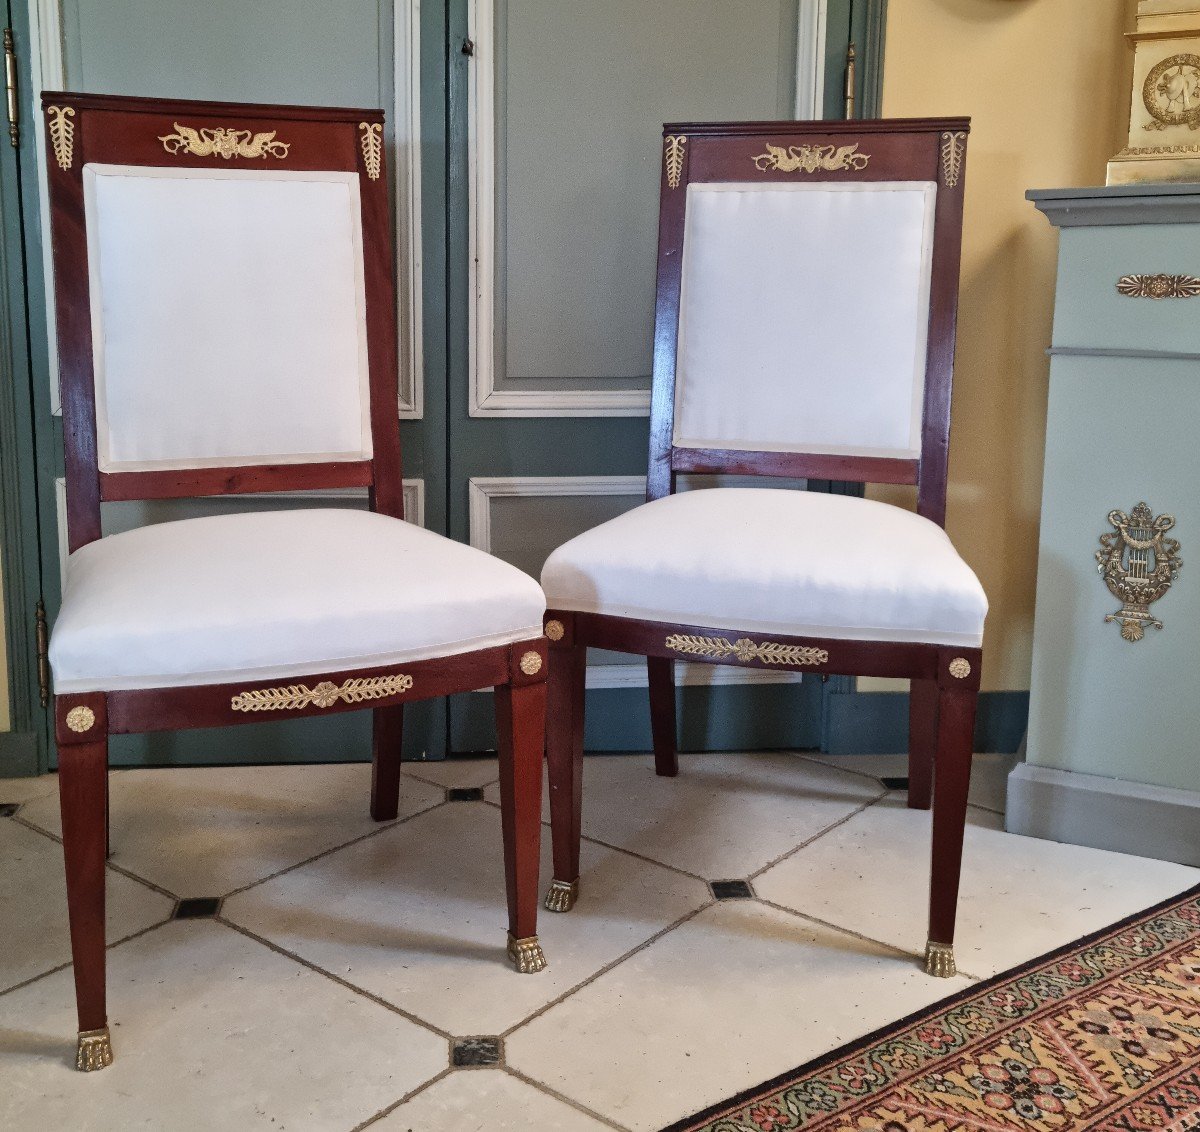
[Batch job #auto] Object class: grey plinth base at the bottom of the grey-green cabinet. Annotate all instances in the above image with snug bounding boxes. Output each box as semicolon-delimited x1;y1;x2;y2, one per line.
1006;762;1200;866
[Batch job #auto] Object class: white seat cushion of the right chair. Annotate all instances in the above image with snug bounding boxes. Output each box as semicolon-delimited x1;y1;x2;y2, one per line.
541;487;988;648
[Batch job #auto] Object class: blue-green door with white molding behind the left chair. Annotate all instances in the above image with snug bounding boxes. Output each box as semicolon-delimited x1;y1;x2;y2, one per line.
16;0;446;765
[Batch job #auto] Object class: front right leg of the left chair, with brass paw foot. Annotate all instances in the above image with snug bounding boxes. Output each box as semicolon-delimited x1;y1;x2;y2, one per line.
496;682;546;975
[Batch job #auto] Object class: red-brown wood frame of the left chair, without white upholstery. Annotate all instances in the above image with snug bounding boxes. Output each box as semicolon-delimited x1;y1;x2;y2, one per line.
42;92;547;1068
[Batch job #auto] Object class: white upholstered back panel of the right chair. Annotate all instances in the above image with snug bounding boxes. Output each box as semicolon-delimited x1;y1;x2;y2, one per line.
673;181;937;457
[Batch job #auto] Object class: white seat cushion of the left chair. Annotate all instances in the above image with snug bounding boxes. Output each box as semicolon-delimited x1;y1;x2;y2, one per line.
50;509;546;693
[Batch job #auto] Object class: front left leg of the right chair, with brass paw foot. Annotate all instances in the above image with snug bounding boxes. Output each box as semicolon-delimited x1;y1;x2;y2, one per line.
546;646;588;912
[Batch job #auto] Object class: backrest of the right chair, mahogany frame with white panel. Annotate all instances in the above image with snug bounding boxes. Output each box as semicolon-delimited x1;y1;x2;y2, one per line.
648;119;970;523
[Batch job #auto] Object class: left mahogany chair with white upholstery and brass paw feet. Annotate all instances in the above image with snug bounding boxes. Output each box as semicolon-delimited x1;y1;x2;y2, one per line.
43;94;546;1070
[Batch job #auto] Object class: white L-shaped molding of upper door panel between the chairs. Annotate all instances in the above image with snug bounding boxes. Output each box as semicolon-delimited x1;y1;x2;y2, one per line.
467;0;650;417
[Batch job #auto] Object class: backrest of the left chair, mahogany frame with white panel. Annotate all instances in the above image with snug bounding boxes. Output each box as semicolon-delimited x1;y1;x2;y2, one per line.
42;94;402;550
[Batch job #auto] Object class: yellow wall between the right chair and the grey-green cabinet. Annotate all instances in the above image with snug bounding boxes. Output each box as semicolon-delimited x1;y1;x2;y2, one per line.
872;0;1133;689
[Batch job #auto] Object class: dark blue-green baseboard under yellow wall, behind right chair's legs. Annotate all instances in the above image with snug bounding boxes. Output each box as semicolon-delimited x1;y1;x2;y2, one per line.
823;691;1030;755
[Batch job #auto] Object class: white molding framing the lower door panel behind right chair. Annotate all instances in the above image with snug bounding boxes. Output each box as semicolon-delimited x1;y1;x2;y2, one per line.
467;475;803;688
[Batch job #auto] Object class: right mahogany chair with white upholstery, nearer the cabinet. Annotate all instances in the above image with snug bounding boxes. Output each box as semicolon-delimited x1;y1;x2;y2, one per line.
542;119;986;976
